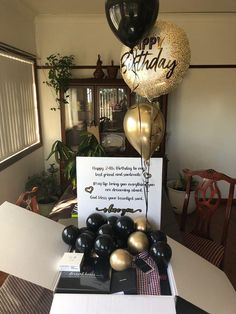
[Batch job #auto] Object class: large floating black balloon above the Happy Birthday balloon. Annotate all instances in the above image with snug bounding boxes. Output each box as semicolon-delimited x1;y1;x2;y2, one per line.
105;0;159;48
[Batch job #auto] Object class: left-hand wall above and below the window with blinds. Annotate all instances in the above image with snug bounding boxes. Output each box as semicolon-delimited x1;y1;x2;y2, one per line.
0;0;44;204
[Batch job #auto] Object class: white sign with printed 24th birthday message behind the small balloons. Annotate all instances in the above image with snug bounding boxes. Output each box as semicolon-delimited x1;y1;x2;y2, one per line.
76;157;162;228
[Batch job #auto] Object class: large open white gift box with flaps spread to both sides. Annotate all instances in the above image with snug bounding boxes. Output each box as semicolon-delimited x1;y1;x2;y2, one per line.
0;202;236;314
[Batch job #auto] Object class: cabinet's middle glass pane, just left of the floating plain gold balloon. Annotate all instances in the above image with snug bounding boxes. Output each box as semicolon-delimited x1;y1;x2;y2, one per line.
98;87;127;132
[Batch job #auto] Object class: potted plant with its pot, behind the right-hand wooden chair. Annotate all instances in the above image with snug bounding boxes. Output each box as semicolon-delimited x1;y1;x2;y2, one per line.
167;172;198;214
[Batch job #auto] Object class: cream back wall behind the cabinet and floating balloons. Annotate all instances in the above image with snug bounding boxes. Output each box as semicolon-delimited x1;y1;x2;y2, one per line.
36;14;236;195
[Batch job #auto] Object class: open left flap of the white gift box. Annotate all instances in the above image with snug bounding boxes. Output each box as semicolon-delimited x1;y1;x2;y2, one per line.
0;202;68;290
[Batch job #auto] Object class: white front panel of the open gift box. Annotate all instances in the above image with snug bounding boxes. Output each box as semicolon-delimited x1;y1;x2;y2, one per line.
50;293;176;314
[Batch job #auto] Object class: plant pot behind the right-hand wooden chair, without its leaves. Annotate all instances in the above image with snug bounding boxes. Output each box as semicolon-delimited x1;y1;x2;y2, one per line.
167;180;196;214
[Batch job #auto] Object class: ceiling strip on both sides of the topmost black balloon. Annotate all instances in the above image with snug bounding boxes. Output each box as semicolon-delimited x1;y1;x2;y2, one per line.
18;0;236;15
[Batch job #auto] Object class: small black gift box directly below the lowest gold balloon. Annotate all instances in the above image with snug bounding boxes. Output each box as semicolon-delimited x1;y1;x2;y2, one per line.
111;268;137;294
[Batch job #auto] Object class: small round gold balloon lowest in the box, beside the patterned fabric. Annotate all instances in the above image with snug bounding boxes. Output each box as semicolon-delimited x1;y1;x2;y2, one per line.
110;249;133;271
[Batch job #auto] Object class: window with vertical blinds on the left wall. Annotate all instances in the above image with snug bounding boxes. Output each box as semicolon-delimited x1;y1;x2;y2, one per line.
0;44;41;170
